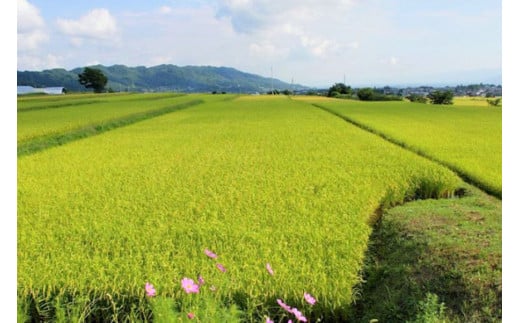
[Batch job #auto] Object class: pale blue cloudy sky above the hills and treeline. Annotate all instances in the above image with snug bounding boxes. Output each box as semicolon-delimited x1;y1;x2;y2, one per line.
17;0;502;87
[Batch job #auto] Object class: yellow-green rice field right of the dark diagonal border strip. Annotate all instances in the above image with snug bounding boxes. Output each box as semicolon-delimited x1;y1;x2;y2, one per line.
300;97;502;197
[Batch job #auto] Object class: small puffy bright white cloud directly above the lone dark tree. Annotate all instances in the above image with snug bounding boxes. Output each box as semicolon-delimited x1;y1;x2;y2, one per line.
56;9;118;43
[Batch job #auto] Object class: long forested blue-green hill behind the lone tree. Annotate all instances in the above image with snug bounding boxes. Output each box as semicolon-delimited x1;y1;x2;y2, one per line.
17;65;307;93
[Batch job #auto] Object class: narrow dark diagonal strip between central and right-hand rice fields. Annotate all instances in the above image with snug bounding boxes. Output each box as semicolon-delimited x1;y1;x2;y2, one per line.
311;103;502;200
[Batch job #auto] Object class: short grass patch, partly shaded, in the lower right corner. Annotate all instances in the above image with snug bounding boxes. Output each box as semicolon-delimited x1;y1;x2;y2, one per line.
351;187;502;322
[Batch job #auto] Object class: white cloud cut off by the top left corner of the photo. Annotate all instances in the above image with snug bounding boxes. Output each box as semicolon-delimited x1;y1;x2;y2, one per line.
17;0;49;51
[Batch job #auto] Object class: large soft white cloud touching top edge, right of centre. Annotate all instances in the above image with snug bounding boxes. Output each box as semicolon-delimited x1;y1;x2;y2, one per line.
217;0;358;59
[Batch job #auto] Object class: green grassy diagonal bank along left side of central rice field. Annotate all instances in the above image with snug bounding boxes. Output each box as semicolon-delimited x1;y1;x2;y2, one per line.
17;99;205;157
